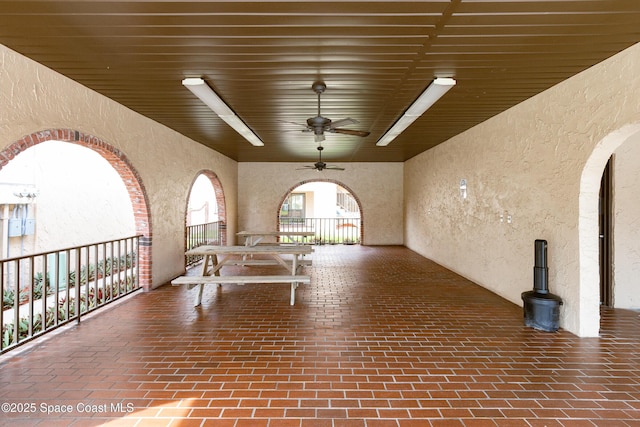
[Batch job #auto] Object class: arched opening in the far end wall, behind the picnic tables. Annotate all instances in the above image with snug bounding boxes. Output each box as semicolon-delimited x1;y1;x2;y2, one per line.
277;180;364;244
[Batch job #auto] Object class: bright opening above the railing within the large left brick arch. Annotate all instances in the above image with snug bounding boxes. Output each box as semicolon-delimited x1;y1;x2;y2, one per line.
0;141;135;254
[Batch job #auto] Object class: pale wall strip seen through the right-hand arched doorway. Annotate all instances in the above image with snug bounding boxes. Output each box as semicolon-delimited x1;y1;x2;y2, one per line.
613;142;640;310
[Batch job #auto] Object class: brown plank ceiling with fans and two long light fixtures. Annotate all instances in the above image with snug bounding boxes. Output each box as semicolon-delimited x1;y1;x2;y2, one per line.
0;0;640;162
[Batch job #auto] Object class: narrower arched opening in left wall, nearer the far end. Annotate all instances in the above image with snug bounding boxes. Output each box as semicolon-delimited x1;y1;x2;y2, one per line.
185;170;227;267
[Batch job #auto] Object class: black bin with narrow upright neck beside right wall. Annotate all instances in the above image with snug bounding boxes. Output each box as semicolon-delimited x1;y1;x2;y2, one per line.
521;240;562;332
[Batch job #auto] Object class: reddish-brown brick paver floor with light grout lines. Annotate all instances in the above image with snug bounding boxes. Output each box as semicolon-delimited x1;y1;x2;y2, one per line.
0;246;640;427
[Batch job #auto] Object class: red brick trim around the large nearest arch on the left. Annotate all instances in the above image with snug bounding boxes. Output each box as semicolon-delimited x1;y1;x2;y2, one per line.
0;129;153;291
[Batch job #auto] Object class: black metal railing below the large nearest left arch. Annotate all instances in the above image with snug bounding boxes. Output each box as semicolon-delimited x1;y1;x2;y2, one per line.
0;236;141;353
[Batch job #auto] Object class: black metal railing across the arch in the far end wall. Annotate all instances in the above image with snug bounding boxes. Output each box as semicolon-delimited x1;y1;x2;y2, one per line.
280;217;362;245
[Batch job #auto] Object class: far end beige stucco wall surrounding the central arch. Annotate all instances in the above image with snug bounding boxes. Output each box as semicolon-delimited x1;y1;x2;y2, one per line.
238;163;403;245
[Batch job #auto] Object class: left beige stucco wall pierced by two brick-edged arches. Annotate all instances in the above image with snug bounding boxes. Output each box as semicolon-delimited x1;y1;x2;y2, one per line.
0;46;237;286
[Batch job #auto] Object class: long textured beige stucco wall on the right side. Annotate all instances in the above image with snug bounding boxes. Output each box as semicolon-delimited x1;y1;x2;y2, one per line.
405;45;640;336
